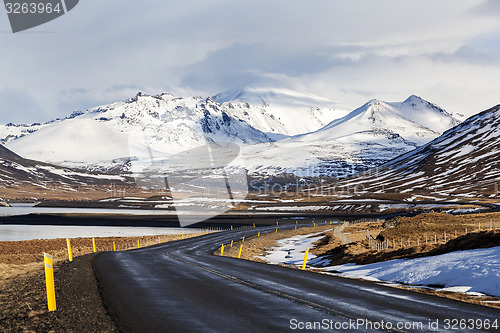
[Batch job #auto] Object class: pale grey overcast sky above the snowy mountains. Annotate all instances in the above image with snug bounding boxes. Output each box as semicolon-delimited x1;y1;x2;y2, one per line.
0;0;500;123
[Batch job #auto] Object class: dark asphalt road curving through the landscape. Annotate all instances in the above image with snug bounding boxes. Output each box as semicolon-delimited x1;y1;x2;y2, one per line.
94;227;500;332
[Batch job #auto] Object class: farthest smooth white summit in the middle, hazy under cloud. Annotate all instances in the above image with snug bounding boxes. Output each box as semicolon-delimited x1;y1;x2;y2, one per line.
213;81;352;135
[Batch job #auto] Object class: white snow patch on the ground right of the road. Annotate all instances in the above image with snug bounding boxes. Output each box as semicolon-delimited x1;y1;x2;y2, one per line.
257;232;500;297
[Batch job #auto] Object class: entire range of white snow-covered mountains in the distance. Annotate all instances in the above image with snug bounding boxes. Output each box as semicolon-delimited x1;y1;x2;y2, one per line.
0;85;460;182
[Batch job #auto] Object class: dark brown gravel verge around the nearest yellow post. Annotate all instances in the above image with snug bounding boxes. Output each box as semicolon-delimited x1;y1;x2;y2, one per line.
0;254;117;332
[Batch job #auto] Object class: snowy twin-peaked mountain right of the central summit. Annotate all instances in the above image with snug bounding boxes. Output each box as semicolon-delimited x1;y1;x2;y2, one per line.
237;96;460;177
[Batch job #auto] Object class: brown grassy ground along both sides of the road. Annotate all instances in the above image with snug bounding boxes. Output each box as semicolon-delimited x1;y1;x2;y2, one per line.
0;213;500;332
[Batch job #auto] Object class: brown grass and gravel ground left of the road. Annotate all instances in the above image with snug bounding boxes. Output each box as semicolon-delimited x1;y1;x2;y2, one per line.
0;234;205;332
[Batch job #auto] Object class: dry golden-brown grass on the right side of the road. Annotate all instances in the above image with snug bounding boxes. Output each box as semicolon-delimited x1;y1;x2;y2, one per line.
221;213;500;308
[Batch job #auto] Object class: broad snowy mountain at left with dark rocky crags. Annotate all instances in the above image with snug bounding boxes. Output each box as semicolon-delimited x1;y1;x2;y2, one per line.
7;94;277;167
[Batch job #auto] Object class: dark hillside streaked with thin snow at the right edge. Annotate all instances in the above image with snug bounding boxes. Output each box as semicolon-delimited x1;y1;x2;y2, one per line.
328;105;500;196
